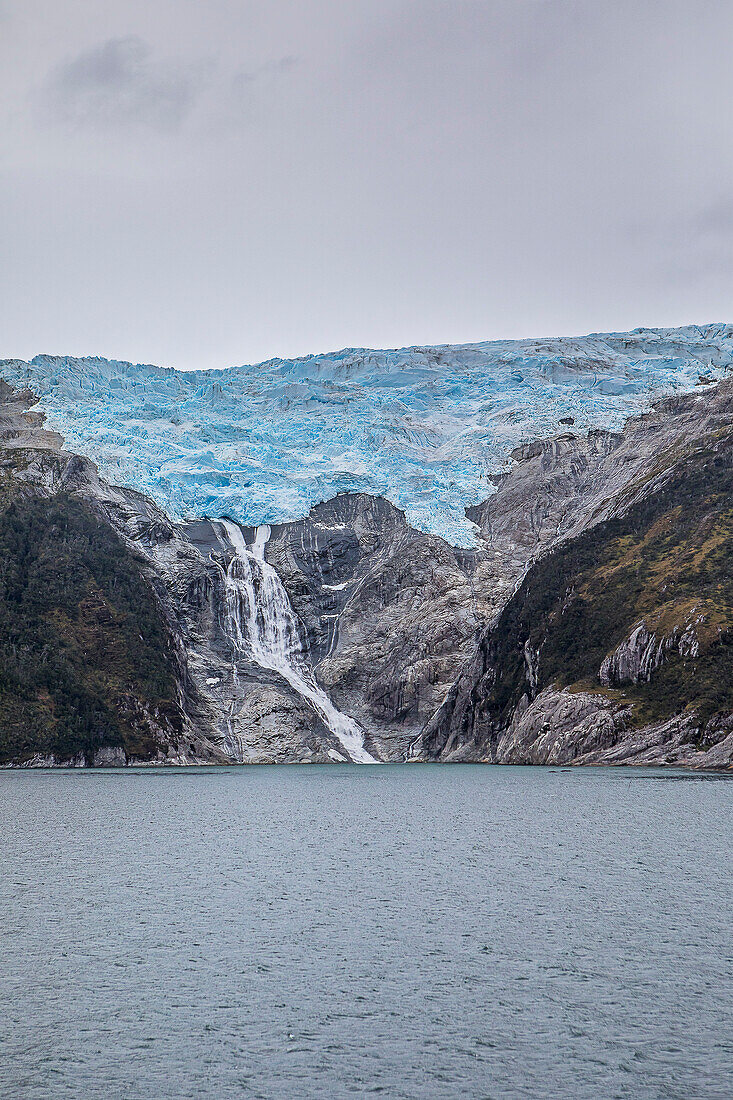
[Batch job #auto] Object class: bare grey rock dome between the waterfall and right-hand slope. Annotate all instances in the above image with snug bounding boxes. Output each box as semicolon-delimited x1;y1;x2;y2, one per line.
266;494;488;760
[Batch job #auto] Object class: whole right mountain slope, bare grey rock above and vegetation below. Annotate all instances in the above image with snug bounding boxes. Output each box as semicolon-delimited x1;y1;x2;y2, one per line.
411;383;733;767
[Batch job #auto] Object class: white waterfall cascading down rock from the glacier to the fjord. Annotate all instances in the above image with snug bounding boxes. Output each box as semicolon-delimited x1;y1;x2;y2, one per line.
218;519;379;763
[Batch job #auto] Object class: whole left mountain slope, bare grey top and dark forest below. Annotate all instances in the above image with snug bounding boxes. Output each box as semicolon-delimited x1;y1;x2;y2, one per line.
0;381;226;765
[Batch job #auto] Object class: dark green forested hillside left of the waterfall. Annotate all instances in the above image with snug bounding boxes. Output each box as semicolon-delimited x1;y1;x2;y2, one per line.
0;482;182;763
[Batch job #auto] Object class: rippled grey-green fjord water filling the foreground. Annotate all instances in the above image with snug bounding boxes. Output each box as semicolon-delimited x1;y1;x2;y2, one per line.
0;765;733;1100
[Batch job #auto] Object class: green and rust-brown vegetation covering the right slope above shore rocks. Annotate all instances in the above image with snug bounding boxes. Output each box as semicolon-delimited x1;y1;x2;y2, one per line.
484;432;733;739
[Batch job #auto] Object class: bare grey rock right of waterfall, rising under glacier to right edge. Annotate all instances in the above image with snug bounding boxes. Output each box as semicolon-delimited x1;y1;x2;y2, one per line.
244;383;733;759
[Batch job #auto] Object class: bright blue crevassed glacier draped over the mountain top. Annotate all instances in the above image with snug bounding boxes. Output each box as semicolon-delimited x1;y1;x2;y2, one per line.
0;325;733;547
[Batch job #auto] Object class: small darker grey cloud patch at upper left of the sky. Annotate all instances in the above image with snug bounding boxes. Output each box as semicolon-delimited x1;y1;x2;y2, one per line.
42;35;199;130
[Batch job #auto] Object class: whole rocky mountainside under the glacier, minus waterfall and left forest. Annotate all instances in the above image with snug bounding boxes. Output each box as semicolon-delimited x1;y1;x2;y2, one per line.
0;382;733;767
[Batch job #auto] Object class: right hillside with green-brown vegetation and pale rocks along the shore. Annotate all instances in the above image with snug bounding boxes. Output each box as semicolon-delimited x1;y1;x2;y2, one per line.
423;426;733;762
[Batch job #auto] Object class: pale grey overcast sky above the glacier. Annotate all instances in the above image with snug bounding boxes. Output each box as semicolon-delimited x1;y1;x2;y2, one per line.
0;0;733;367
